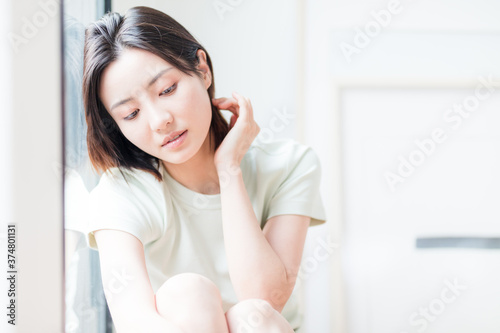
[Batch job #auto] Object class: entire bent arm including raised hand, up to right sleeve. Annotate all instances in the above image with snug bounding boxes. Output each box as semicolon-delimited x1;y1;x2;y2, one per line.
212;93;309;312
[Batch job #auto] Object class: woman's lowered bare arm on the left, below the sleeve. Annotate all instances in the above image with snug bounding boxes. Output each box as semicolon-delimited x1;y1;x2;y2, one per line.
94;229;183;333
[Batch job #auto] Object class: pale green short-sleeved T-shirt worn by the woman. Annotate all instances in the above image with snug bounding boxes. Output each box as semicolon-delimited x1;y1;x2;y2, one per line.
86;139;326;329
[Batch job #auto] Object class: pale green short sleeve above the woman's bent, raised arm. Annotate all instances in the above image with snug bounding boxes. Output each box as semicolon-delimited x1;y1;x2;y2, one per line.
266;144;326;226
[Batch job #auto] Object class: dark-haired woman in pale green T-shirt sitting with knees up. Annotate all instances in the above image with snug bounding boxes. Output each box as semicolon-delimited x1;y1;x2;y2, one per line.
83;7;326;333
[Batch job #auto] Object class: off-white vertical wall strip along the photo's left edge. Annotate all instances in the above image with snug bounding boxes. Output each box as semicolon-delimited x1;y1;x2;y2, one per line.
0;0;64;332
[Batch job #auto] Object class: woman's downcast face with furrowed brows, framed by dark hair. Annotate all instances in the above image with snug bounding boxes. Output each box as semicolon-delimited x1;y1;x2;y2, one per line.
99;49;212;164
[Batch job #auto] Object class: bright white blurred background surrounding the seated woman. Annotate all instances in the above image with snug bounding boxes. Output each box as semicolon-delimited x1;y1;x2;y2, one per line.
0;0;500;333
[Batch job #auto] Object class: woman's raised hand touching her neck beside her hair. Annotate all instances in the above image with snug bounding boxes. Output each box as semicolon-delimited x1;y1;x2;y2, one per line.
212;92;260;171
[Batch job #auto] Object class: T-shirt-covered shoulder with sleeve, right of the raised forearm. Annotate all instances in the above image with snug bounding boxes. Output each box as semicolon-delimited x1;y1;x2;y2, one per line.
247;139;326;228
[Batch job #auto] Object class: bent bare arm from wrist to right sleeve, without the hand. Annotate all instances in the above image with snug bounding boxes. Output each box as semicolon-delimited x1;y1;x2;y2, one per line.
219;168;310;312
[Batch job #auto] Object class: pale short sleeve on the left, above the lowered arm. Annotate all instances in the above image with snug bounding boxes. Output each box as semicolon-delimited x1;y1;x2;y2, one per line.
86;173;159;250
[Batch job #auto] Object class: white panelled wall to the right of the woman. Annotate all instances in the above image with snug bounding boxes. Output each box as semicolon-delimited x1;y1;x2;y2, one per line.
305;0;500;333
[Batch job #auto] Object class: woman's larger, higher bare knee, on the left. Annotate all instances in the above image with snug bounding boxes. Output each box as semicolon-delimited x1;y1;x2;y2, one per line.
155;273;229;333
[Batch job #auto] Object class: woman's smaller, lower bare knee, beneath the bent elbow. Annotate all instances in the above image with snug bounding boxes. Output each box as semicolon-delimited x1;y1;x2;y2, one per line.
226;298;293;333
